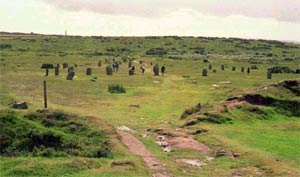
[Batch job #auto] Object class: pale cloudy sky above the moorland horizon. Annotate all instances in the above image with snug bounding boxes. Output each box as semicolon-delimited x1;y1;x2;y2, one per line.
0;0;300;41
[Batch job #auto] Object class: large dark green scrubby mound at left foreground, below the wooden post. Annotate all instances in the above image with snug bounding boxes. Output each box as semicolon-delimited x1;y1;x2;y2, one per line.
0;110;112;157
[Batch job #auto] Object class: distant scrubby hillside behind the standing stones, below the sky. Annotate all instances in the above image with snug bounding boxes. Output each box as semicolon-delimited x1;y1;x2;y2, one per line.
0;32;300;62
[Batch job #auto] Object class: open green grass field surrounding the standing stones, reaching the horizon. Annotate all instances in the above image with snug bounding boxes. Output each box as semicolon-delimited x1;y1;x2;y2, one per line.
0;35;300;177
